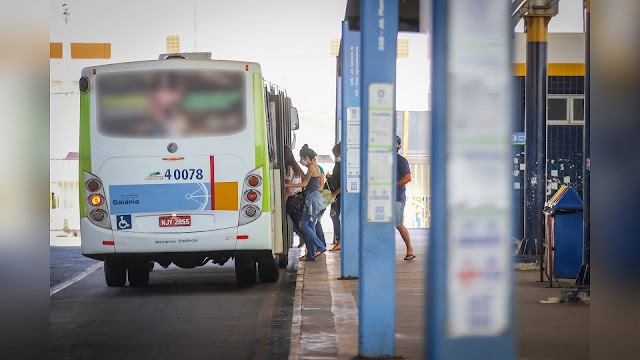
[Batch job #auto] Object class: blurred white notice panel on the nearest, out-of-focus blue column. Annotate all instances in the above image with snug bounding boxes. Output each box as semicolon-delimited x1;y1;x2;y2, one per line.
444;0;510;338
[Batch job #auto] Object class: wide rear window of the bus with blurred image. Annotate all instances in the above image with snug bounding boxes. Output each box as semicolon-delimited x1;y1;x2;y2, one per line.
96;69;246;138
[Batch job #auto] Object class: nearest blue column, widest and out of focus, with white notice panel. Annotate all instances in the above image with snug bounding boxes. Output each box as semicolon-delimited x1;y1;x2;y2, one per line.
425;0;515;360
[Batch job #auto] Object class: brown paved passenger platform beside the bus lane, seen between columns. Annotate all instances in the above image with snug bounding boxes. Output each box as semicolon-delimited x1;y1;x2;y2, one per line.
289;229;589;360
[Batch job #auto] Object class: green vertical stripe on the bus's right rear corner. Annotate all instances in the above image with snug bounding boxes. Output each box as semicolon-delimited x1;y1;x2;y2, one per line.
253;73;271;212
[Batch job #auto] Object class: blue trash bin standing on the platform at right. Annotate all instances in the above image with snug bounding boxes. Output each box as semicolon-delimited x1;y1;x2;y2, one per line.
544;185;584;279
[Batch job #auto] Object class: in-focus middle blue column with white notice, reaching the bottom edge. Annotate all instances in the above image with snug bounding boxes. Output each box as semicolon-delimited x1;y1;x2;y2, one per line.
358;0;398;358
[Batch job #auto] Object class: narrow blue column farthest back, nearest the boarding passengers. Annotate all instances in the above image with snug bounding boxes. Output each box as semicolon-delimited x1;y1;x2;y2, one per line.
340;21;360;278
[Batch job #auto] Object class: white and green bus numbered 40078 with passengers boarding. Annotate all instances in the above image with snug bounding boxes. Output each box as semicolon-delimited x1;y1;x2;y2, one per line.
79;53;298;286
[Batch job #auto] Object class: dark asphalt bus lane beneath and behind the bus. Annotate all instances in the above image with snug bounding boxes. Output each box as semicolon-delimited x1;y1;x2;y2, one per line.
49;248;296;359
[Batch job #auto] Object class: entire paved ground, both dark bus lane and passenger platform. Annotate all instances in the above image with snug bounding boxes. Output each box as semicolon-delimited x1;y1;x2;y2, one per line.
50;230;590;360
